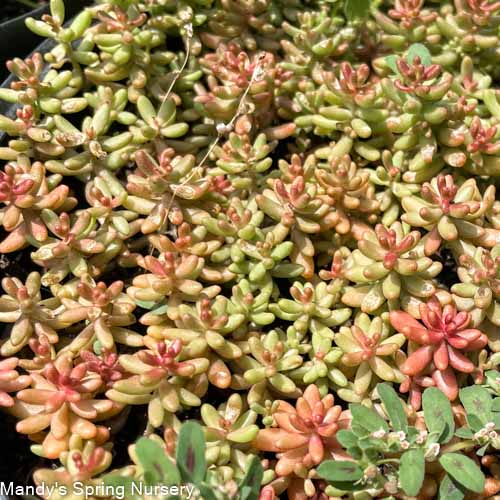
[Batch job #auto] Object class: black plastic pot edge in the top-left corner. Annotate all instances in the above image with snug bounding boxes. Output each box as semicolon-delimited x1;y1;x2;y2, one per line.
0;0;89;80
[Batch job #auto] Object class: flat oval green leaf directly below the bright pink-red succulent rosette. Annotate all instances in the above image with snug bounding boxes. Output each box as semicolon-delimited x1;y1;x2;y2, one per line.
422;387;455;443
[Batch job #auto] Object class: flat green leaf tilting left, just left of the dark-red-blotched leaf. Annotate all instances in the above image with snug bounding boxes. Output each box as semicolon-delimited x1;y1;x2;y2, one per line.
135;438;181;485
